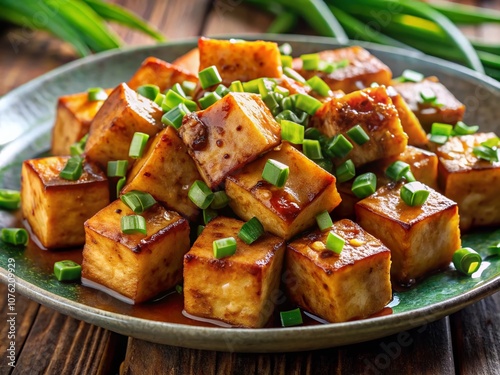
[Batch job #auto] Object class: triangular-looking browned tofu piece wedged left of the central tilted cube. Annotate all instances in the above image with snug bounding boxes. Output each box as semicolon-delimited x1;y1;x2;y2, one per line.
122;126;201;220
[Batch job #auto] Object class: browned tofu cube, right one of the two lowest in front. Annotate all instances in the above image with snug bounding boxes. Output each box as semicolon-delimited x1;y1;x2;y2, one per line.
284;219;392;323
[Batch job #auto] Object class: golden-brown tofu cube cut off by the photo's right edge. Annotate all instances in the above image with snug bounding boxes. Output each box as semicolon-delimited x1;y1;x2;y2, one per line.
436;133;500;230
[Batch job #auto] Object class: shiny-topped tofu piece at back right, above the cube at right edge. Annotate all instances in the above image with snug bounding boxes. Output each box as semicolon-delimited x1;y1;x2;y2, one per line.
393;77;465;132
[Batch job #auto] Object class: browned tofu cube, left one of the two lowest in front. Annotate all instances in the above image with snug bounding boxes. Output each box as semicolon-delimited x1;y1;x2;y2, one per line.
183;217;286;328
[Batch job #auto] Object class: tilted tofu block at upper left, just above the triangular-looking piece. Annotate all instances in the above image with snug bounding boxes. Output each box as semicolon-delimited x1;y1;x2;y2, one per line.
85;83;163;168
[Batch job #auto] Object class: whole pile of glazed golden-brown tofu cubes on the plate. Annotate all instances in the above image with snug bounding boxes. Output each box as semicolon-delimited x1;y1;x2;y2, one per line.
22;38;500;328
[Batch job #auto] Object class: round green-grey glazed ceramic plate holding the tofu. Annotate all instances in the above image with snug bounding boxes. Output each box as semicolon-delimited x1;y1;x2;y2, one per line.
0;35;500;352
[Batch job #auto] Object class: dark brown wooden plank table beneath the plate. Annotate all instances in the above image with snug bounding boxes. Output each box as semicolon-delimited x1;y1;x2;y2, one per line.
0;0;500;374
